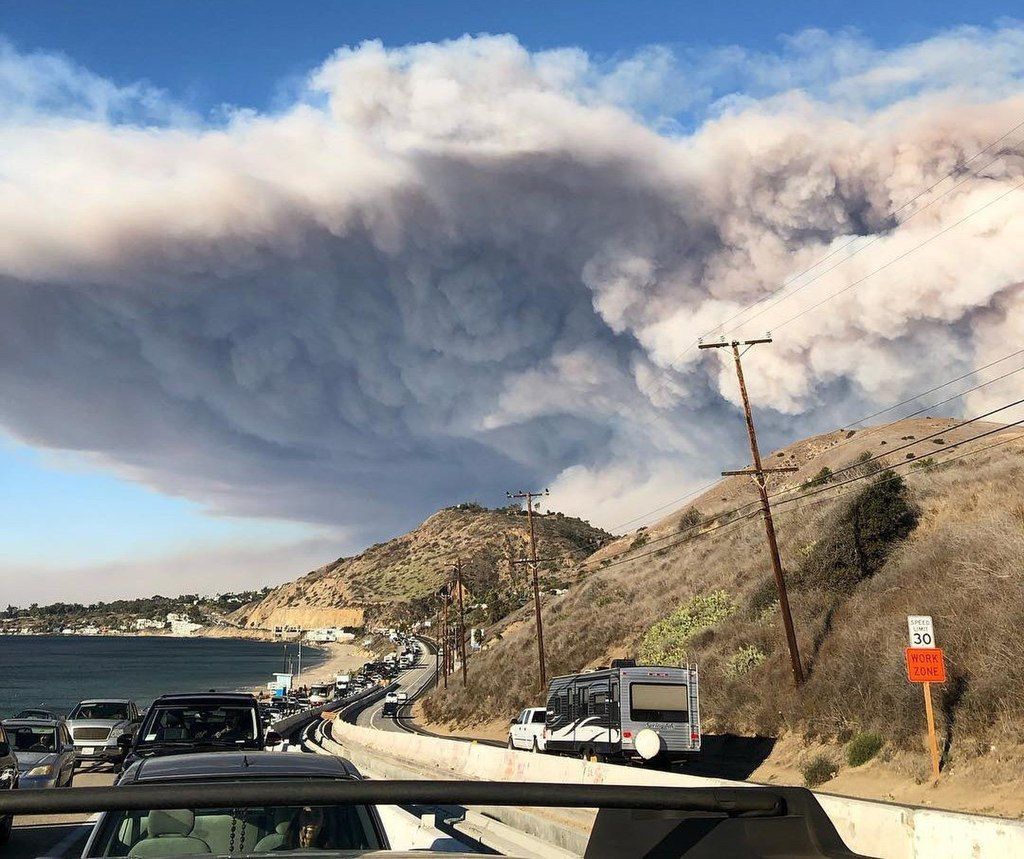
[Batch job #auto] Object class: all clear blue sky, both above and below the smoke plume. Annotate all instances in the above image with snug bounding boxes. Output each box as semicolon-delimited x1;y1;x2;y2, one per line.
0;0;1015;601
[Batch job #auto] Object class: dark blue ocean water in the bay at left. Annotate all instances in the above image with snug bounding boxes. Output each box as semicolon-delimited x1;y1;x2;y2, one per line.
0;636;327;718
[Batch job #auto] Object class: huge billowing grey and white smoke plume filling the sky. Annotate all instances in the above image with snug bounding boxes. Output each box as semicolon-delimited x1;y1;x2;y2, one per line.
0;29;1024;542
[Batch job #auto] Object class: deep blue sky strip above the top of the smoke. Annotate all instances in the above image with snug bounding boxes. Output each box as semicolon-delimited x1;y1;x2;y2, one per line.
0;0;1018;110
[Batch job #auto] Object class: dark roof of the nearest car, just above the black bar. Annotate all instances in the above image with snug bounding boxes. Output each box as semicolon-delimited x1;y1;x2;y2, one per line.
118;751;359;785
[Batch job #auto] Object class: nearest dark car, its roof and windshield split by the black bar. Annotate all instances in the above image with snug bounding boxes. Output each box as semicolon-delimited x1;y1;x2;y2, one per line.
82;751;389;859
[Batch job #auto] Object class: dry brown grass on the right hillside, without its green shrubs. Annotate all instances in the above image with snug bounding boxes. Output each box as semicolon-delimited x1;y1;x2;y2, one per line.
424;439;1024;756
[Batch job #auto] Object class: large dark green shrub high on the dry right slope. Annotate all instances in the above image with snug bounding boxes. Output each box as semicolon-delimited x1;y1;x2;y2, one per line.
794;471;918;591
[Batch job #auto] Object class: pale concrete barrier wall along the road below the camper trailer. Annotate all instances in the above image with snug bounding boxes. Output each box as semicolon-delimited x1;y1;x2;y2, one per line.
331;721;1024;859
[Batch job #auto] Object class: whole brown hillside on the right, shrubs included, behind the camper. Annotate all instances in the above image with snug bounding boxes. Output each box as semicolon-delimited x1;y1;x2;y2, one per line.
424;419;1024;814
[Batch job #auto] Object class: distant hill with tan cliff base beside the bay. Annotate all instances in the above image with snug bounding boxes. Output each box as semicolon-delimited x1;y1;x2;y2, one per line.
232;504;611;628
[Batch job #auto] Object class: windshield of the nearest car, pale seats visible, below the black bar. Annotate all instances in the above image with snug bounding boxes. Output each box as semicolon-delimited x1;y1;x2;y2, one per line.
86;806;382;857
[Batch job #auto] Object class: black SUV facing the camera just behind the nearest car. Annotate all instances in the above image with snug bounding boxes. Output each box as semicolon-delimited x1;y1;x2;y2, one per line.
119;692;282;767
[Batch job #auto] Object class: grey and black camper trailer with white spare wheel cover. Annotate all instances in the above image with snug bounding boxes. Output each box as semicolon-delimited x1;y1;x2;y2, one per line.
544;659;700;762
